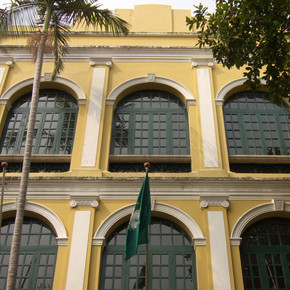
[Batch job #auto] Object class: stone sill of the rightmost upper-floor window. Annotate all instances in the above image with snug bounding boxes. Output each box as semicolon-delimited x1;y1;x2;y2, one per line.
229;155;290;164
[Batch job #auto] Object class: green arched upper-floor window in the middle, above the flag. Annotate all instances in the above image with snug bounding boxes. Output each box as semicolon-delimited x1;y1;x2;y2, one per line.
111;90;189;155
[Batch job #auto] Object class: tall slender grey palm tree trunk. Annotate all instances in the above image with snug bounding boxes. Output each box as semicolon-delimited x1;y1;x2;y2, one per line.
6;9;51;290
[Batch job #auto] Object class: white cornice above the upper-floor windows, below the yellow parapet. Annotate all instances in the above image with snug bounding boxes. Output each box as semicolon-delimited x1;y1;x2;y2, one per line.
0;45;214;66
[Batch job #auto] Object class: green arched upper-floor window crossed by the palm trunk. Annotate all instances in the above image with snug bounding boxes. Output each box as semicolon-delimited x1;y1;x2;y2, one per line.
0;89;78;154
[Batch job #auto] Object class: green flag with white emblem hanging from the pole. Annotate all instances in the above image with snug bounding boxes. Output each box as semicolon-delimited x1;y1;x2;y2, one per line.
125;172;151;260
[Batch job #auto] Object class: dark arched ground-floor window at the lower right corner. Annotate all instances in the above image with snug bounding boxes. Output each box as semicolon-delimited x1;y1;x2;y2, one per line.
240;218;290;290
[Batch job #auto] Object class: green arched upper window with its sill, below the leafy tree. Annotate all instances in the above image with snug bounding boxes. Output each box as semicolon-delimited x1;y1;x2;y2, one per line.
224;91;290;171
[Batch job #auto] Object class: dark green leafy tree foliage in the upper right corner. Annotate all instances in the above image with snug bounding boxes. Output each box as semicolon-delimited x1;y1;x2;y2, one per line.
186;0;290;103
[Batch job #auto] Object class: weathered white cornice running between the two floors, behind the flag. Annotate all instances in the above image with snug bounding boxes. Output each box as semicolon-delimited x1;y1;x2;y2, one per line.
5;175;290;201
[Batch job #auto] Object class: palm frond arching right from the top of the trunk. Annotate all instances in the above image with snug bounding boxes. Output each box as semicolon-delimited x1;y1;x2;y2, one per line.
56;0;129;35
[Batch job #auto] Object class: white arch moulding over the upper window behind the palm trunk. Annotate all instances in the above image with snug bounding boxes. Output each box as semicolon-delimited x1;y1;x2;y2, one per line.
0;76;86;104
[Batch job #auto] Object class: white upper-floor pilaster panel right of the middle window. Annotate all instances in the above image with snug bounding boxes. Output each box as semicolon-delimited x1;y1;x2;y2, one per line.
197;68;219;168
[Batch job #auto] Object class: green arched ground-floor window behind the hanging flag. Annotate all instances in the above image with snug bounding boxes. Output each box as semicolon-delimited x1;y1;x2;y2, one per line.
100;217;197;290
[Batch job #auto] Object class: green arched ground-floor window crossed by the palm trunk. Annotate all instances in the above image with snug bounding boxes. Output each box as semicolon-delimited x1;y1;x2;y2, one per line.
0;217;57;290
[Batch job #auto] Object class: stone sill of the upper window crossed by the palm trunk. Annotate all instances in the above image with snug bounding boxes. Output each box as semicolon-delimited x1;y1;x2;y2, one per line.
0;154;71;163
